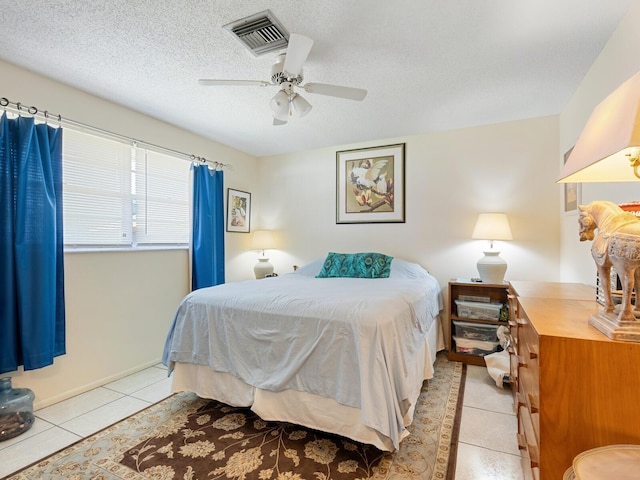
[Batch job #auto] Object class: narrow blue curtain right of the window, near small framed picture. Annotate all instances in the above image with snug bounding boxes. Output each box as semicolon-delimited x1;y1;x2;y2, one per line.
191;165;224;290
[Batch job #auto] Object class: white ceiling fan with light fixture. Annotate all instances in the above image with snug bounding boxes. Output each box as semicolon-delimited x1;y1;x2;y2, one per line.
198;33;367;125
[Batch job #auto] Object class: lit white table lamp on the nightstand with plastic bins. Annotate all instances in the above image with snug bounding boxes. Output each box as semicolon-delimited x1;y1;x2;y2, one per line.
471;213;513;284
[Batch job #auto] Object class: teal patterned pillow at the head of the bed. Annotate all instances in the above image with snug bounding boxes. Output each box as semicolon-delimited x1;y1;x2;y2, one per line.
316;252;393;278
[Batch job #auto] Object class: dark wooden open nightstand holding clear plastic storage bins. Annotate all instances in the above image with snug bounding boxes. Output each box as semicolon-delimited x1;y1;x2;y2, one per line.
449;279;509;366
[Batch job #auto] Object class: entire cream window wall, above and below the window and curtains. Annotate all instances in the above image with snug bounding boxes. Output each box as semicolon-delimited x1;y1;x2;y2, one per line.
0;58;257;408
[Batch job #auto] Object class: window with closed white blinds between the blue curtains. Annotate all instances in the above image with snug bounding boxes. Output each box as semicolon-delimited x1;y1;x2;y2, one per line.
63;128;190;248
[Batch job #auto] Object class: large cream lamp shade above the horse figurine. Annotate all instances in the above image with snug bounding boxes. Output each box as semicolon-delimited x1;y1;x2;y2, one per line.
558;72;640;183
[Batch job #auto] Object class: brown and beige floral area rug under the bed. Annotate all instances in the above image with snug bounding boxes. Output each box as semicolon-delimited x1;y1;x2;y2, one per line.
8;352;464;480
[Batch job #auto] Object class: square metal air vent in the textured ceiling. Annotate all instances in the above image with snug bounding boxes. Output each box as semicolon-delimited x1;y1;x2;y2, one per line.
223;10;289;57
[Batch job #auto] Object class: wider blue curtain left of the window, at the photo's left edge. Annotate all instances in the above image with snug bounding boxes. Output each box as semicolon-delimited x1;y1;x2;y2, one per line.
0;114;65;373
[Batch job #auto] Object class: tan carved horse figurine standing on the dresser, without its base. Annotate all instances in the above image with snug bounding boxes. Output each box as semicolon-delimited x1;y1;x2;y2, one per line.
578;201;640;328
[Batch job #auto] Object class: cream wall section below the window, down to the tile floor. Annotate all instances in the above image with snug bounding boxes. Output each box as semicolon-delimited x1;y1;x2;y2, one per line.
13;250;189;408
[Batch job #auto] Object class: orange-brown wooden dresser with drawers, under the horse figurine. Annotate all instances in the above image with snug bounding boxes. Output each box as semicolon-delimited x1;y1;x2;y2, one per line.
509;281;640;480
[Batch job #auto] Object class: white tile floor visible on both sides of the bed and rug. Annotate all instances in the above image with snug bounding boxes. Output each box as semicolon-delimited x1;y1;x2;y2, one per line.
0;365;522;480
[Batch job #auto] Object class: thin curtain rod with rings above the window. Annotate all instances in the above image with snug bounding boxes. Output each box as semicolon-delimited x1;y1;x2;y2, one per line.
0;97;231;169
